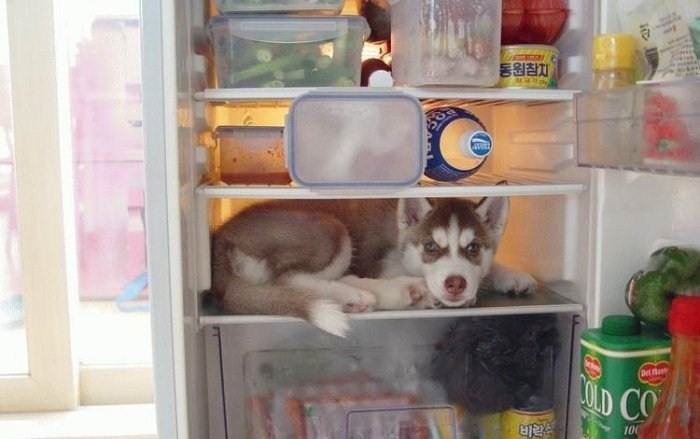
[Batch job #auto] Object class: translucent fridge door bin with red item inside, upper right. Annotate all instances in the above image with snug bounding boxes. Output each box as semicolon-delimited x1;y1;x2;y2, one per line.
575;80;700;175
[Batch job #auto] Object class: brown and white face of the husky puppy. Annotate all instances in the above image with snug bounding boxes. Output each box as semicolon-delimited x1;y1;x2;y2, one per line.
401;199;503;307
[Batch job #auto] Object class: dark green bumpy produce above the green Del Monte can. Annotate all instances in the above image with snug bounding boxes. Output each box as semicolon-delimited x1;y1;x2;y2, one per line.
625;246;700;326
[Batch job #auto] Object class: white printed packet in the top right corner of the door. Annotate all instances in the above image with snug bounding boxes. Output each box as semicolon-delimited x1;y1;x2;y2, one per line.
617;0;700;81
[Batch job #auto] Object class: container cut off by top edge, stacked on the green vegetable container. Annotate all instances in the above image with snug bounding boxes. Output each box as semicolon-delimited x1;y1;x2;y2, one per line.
216;0;344;15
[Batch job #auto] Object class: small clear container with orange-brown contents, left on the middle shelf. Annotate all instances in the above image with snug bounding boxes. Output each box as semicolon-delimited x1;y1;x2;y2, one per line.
209;126;291;184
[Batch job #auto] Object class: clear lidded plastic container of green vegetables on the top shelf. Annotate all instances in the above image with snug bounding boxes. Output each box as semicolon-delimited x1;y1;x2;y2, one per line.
208;15;369;88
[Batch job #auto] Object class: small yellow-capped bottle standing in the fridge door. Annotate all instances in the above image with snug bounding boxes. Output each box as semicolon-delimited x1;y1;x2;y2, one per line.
593;33;635;90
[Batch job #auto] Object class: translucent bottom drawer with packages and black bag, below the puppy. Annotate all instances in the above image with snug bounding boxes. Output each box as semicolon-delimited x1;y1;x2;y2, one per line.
206;314;574;439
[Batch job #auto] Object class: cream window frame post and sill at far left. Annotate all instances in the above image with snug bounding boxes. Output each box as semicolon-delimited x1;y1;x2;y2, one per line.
0;0;153;413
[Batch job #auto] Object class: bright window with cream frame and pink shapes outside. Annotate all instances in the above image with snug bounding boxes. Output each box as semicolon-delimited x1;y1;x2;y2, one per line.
0;0;153;412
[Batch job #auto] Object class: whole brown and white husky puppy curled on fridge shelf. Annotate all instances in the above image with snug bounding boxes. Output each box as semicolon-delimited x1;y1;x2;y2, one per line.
212;197;535;336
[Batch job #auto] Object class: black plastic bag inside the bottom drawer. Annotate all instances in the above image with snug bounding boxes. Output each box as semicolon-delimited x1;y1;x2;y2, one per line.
432;315;559;414
